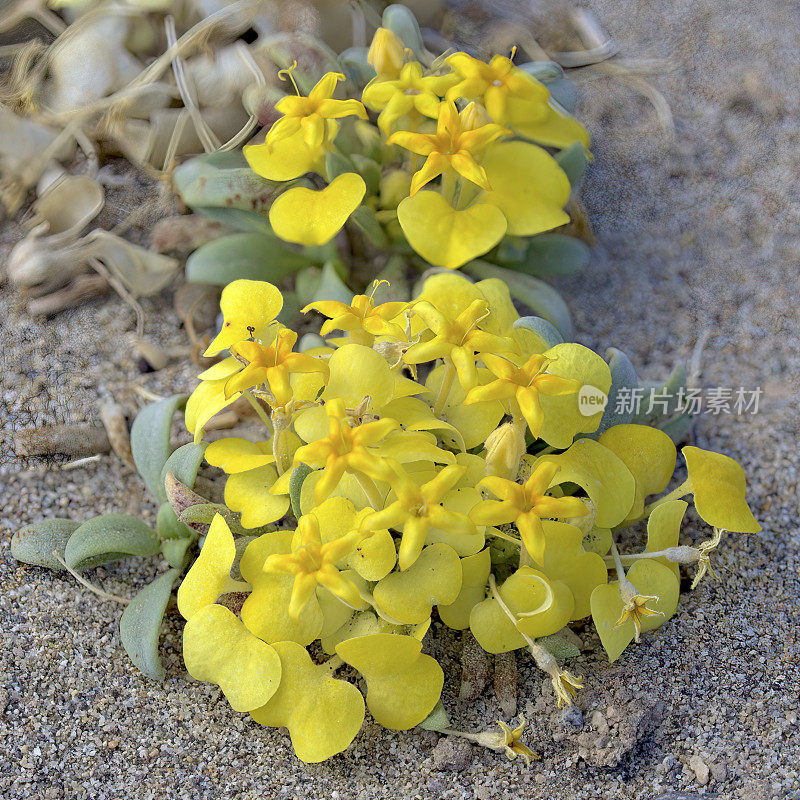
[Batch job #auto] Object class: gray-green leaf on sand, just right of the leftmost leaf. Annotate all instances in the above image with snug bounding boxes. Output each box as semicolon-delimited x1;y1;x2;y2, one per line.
64;514;160;570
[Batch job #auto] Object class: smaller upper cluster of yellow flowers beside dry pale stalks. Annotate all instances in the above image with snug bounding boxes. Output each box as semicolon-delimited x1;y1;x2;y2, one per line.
244;28;589;269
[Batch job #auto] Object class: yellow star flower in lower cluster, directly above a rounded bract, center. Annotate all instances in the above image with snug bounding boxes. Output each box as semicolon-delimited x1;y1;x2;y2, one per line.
362;465;477;570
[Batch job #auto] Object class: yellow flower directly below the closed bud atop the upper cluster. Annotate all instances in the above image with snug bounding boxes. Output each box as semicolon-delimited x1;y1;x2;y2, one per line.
362;61;458;135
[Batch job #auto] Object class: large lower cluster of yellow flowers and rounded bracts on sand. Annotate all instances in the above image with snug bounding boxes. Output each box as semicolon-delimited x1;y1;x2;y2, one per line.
178;274;758;762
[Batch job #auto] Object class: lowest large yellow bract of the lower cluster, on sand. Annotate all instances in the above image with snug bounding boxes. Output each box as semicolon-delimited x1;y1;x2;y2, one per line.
250;642;364;764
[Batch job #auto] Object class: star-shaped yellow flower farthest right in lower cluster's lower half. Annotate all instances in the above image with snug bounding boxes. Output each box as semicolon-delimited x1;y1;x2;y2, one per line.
470;462;589;564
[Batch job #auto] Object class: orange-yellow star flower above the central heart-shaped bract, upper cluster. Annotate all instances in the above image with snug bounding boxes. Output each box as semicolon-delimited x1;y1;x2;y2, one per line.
387;101;508;196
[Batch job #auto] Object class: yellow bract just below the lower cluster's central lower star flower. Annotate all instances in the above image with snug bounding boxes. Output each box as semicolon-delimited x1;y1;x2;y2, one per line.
372;544;461;625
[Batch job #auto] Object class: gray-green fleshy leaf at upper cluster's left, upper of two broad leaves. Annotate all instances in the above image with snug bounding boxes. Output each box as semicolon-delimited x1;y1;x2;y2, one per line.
172;150;284;212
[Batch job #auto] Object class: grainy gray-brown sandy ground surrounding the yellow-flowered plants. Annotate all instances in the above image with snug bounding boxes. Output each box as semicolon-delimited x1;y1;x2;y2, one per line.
0;0;800;800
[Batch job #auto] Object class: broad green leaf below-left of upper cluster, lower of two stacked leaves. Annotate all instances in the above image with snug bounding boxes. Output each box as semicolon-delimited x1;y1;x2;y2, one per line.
186;233;310;286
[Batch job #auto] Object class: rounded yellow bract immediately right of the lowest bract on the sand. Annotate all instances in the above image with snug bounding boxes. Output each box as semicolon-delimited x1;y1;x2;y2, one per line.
336;633;444;731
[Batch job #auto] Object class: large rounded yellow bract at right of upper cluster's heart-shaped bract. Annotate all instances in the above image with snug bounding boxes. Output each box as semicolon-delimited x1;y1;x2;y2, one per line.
480;142;570;236
